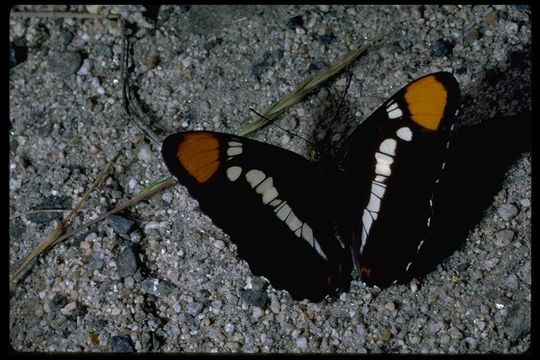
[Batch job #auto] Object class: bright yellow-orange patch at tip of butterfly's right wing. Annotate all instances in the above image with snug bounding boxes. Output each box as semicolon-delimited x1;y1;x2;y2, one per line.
405;75;448;131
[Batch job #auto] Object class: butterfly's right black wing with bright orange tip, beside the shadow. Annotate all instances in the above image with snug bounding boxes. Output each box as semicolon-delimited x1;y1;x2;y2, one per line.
338;72;459;287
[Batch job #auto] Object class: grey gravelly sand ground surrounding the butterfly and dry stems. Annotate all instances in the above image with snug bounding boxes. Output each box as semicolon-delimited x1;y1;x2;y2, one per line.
9;5;532;353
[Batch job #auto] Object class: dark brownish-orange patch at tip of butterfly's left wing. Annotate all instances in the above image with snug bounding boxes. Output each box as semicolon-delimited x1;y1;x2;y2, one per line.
176;132;219;184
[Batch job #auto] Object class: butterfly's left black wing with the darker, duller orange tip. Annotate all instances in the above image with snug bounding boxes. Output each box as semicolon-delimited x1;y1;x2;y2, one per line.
162;131;352;301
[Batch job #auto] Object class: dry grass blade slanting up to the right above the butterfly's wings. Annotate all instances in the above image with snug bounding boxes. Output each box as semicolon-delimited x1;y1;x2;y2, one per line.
237;46;366;136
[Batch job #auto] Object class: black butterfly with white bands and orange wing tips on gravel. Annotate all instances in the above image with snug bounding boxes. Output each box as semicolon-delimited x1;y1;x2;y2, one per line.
162;72;459;302
